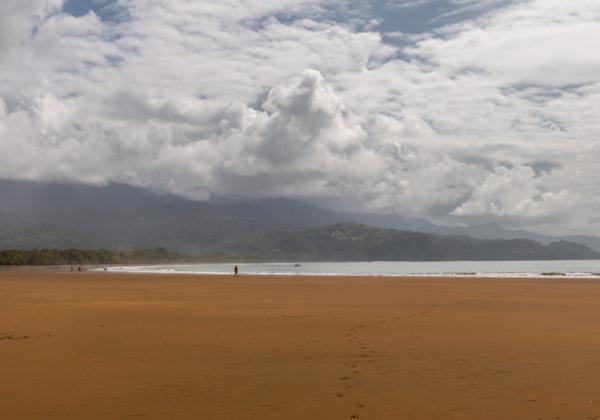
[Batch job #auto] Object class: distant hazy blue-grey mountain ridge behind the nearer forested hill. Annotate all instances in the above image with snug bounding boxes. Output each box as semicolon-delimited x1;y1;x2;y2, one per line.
0;180;600;260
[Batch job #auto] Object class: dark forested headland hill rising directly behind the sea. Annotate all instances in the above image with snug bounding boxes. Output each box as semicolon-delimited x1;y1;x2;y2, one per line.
234;223;600;261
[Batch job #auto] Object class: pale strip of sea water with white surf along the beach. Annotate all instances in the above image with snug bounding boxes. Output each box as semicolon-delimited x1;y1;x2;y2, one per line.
107;260;600;278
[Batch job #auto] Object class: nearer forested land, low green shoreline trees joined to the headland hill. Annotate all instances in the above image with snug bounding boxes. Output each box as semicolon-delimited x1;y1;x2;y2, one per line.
0;223;600;265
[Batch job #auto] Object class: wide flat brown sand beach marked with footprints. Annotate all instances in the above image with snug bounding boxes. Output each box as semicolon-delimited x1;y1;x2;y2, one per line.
0;270;600;420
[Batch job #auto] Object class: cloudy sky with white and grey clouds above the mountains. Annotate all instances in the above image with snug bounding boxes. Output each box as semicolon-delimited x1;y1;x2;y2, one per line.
0;0;600;235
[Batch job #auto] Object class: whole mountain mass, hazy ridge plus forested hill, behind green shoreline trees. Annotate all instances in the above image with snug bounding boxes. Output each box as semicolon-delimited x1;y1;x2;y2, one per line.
0;180;600;260
